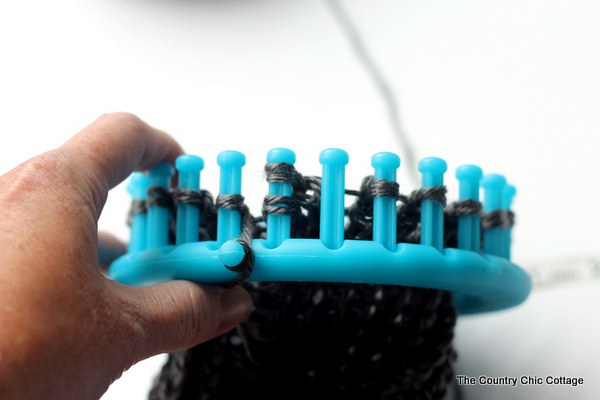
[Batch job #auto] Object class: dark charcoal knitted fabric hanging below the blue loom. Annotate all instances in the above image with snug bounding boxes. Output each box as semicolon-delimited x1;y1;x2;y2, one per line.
150;282;456;400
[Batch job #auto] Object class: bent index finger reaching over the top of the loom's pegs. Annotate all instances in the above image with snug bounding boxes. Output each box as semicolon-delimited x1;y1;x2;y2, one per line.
59;113;183;209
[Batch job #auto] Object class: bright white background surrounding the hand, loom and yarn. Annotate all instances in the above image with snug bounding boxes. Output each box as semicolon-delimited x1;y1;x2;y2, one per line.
0;0;600;400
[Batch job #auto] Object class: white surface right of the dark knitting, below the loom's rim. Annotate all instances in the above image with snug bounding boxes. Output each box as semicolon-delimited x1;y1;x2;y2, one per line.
455;281;600;400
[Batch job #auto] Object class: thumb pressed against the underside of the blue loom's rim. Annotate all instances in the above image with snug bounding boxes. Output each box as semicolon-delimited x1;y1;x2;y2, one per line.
109;281;252;363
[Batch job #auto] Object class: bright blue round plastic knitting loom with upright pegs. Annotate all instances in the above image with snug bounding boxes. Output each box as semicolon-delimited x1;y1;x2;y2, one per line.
109;149;531;314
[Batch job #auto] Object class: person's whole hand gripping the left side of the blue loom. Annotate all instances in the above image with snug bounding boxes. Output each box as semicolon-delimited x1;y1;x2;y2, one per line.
0;113;252;400
